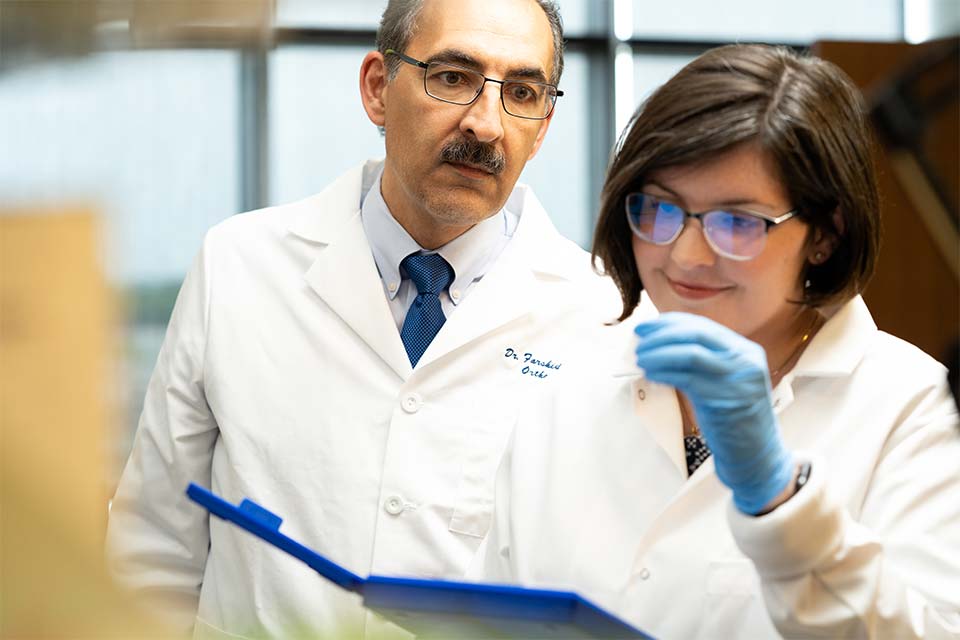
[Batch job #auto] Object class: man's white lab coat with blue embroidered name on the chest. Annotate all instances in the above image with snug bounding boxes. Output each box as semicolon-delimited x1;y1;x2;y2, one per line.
107;162;632;637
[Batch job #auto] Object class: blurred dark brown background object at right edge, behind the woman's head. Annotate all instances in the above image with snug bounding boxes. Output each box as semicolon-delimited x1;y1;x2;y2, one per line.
813;38;960;358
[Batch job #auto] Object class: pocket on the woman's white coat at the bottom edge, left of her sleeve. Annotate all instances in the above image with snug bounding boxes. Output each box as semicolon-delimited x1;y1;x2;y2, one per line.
699;559;764;638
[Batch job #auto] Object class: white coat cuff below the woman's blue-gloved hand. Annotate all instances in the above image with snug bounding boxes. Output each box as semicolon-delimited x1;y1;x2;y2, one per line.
727;452;844;578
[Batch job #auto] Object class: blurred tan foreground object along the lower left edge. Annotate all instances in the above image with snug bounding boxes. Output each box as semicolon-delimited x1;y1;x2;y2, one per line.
0;211;166;638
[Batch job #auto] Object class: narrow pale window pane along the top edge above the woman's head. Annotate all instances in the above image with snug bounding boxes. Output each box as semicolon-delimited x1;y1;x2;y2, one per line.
633;0;902;43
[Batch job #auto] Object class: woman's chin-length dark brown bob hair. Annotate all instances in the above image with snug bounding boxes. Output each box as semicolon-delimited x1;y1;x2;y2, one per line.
593;45;880;320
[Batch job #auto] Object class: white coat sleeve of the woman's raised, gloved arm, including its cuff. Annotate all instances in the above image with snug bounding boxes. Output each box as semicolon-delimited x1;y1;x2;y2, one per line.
727;385;960;639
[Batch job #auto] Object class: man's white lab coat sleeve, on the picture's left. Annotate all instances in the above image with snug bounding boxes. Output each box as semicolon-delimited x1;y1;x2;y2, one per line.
106;243;218;633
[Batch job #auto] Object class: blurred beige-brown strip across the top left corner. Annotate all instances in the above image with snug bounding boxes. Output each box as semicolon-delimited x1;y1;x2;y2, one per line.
0;0;274;72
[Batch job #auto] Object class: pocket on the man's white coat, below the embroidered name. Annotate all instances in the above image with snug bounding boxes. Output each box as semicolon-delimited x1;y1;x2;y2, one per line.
450;418;514;538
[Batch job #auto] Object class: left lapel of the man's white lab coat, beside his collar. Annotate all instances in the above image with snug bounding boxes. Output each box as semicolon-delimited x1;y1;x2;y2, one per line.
296;188;412;380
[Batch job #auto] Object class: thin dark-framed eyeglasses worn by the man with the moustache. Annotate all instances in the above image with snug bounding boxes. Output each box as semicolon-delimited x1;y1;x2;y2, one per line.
386;49;563;120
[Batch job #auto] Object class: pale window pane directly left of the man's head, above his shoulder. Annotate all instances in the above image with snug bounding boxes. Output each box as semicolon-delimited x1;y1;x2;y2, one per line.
269;46;384;204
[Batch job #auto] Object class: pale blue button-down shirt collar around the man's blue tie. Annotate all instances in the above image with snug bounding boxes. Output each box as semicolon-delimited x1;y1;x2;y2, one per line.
360;167;510;304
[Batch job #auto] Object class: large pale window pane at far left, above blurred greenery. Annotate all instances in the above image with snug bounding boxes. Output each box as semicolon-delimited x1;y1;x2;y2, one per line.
0;51;238;284
